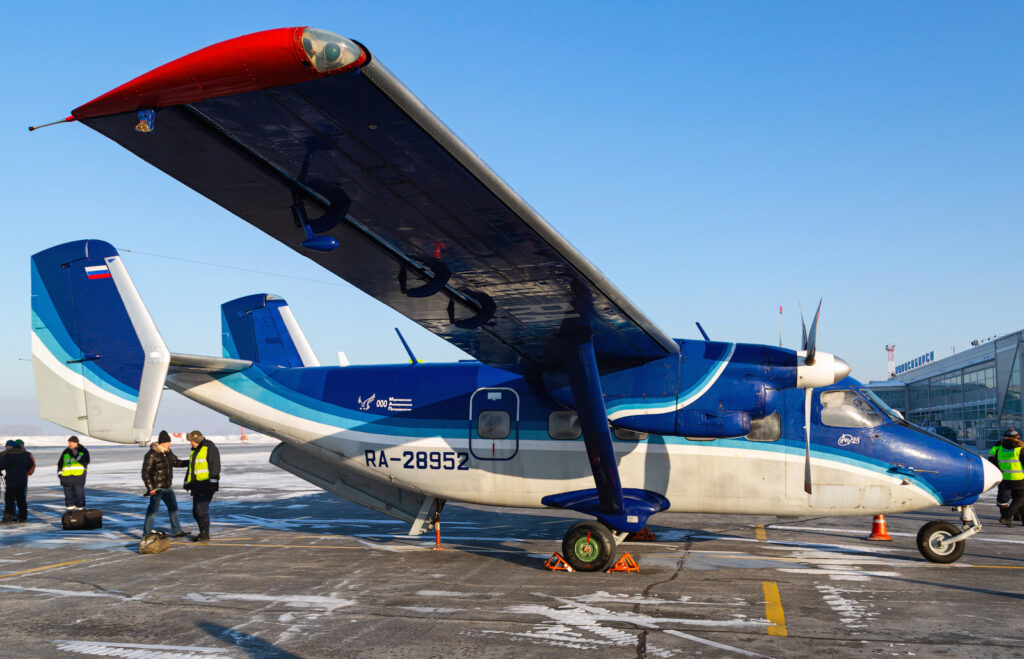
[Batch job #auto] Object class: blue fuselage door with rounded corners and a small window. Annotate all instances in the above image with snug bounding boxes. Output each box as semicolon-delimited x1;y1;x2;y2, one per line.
469;387;519;460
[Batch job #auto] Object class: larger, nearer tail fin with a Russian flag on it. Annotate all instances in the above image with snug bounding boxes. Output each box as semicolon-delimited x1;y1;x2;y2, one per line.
32;239;170;443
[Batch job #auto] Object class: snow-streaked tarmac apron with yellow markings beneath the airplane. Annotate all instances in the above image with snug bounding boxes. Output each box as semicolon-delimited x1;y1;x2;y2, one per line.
0;438;1024;657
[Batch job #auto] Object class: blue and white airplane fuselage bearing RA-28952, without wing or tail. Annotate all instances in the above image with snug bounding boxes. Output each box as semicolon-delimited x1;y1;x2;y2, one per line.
168;352;990;515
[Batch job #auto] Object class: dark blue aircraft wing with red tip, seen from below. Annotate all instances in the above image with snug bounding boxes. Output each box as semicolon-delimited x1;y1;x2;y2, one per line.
73;28;678;374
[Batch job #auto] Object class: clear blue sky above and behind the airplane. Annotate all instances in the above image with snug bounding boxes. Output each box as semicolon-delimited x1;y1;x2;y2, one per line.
0;2;1024;434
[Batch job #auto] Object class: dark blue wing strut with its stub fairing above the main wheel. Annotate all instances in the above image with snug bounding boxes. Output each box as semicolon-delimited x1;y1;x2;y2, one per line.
541;334;669;532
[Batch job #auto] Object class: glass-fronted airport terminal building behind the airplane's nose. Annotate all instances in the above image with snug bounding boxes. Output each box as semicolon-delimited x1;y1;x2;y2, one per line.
867;332;1024;450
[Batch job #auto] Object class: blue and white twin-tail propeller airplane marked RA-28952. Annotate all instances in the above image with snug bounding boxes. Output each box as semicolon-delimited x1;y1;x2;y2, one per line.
32;27;1001;572
